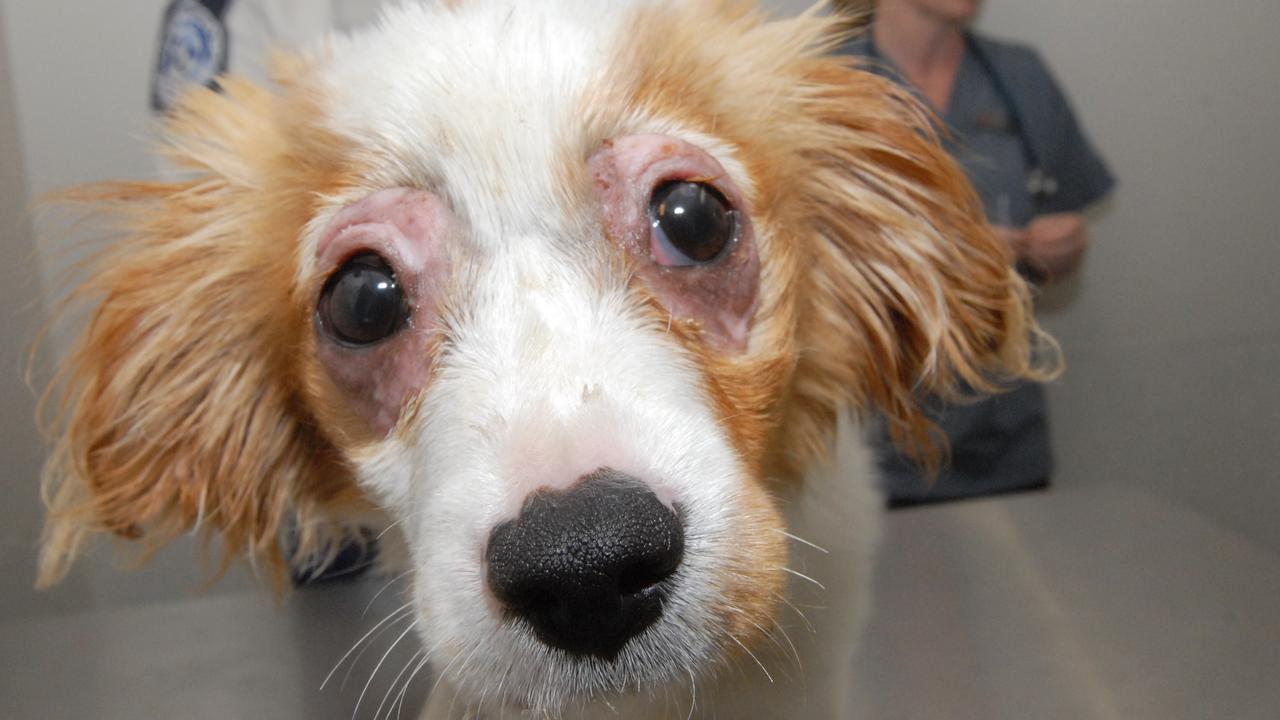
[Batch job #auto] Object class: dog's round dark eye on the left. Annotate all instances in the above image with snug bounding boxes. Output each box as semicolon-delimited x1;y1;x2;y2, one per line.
316;252;408;347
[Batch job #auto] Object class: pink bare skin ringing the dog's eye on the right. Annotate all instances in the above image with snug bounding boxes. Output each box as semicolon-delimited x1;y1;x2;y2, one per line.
588;135;760;354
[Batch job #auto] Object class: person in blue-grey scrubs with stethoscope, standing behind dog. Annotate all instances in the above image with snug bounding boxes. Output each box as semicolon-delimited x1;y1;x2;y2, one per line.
836;0;1115;506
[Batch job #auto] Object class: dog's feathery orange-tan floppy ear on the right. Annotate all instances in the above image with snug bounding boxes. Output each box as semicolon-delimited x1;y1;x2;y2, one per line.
780;49;1051;464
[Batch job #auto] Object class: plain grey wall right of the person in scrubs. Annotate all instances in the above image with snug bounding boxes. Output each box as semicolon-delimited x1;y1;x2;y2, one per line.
982;0;1280;548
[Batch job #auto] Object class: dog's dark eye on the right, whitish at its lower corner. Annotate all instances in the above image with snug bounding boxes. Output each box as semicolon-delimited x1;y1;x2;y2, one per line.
649;181;737;265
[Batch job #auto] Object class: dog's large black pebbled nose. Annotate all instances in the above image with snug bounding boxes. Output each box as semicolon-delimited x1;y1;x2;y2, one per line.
485;469;685;660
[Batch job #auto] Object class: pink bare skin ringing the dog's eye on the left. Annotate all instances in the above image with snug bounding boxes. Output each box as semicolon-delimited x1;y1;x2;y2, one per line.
316;188;456;436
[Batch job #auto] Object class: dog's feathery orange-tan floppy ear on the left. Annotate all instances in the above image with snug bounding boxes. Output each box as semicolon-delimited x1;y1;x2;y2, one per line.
40;79;360;585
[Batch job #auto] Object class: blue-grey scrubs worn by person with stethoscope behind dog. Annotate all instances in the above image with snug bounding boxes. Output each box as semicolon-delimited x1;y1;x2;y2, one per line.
844;30;1115;505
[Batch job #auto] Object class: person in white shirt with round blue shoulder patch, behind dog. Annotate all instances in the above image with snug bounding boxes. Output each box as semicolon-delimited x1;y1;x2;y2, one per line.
151;0;383;585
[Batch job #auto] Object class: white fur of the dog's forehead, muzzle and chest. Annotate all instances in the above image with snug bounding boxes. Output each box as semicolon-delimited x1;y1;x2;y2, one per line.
295;0;878;717
